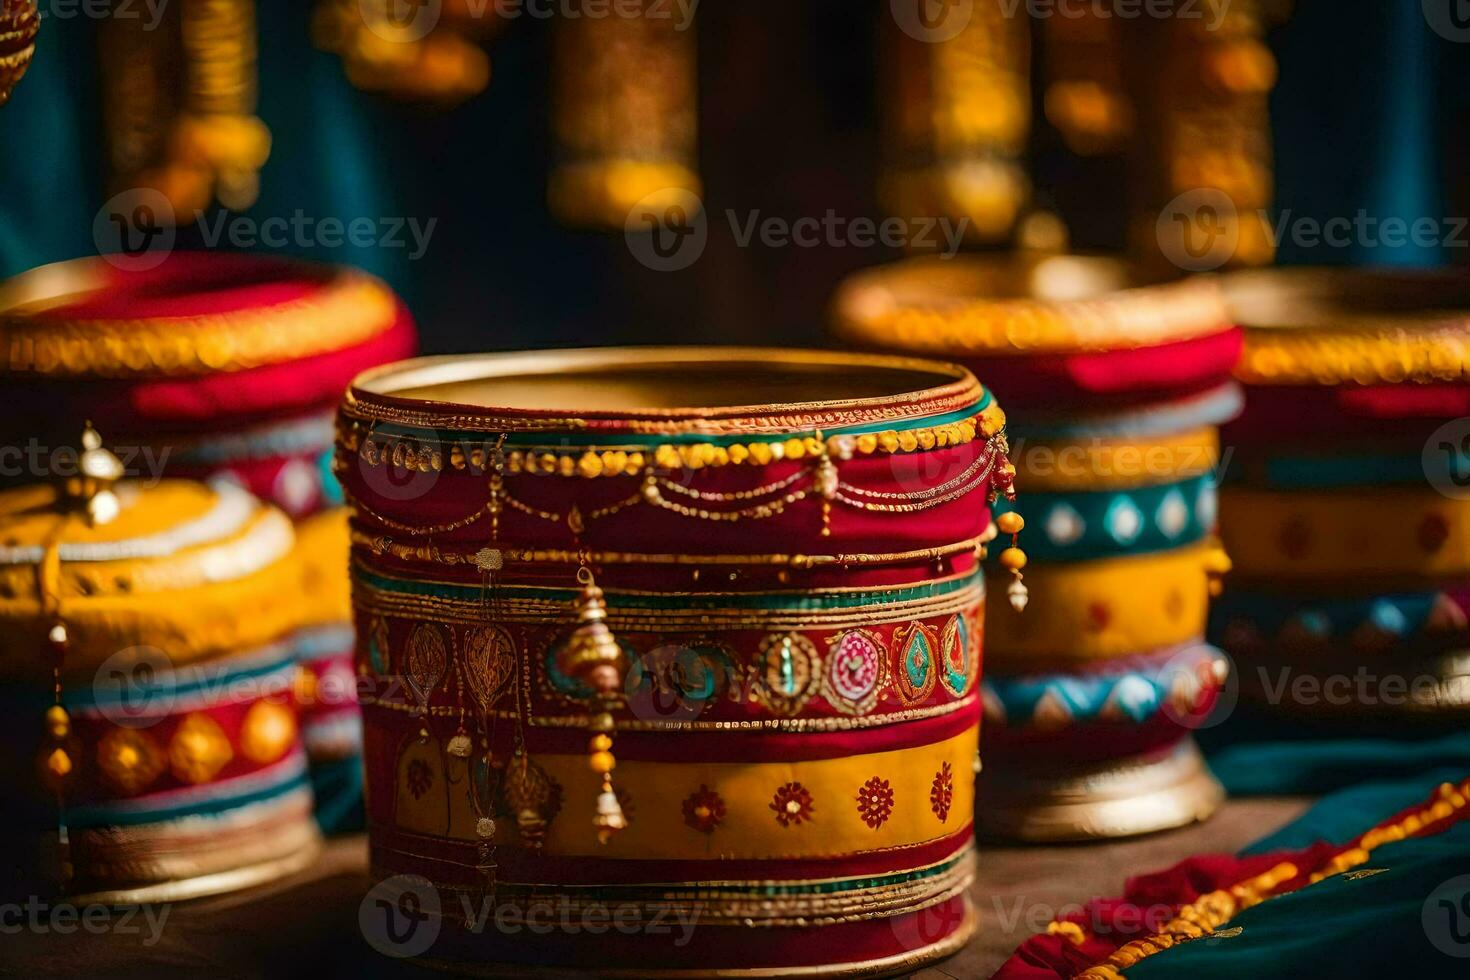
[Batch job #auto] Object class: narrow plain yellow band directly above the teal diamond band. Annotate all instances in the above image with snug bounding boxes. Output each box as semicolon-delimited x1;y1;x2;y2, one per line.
1010;426;1220;490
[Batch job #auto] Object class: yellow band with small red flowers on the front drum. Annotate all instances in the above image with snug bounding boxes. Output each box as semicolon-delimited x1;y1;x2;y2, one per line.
394;729;979;861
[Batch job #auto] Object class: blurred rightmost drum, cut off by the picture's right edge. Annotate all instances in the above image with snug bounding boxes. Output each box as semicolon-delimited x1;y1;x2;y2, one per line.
1213;269;1470;726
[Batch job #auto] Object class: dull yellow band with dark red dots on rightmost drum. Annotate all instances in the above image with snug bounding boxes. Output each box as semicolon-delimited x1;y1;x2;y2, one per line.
1220;486;1470;585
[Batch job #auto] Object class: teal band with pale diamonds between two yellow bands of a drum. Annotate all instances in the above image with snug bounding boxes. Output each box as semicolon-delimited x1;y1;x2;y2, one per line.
992;473;1217;561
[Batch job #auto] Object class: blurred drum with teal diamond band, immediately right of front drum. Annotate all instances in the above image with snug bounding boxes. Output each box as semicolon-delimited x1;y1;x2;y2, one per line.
835;256;1241;840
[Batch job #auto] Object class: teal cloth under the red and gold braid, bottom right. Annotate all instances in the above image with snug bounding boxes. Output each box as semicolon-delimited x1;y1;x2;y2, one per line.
1126;767;1470;980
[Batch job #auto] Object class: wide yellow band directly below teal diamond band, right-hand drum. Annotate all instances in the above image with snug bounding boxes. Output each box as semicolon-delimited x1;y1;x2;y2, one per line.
985;544;1227;673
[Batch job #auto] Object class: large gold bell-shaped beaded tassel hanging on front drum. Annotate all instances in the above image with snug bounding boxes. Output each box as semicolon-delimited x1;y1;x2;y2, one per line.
557;566;628;843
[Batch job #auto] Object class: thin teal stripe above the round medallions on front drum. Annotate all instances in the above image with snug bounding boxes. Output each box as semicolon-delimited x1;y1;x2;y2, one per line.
353;567;983;613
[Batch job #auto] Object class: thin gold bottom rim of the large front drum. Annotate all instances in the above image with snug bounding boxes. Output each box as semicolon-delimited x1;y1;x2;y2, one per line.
413;895;979;980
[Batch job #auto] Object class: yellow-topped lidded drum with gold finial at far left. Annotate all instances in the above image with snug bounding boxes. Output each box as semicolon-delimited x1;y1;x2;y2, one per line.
0;430;320;904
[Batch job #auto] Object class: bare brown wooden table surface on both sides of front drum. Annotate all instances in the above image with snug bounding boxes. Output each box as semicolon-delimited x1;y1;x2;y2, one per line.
0;798;1308;980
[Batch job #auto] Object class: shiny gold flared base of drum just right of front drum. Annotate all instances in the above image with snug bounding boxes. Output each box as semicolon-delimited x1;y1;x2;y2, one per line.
976;738;1225;843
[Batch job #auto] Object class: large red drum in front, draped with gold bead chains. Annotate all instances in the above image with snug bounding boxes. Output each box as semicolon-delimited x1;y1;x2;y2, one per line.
337;348;1011;976
